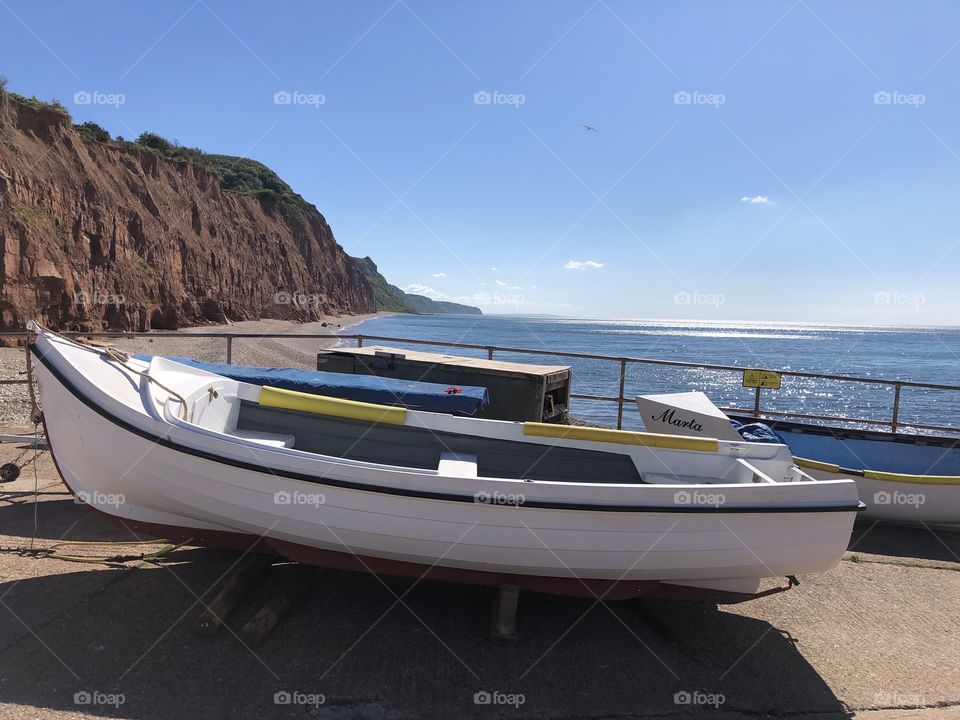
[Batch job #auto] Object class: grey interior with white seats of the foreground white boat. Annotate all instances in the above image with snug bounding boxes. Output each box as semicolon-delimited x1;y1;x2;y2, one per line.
159;358;813;484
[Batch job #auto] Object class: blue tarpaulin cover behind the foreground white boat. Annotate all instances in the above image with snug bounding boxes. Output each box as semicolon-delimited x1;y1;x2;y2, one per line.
137;355;490;415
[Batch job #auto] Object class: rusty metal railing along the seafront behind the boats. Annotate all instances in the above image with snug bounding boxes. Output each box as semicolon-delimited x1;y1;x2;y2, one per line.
0;331;960;433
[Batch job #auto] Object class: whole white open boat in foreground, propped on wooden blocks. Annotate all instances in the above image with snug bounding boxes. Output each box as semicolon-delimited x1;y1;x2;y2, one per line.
30;326;859;602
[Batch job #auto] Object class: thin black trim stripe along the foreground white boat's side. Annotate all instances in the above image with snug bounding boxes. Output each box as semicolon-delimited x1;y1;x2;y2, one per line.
30;343;862;514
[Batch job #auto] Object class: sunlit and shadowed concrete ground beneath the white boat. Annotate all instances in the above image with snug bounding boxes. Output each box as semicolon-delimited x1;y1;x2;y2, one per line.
0;436;960;720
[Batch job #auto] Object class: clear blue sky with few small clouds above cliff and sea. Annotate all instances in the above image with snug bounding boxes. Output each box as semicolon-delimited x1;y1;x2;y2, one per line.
0;0;960;324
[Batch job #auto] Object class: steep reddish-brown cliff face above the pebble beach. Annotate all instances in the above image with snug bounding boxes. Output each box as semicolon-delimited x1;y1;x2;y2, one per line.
0;100;376;330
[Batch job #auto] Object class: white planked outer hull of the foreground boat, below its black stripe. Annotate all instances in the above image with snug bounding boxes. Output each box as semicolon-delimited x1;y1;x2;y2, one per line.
35;338;855;601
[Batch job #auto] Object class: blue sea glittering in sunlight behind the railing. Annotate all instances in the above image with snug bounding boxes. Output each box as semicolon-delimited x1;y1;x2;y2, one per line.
342;315;960;434
